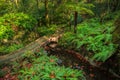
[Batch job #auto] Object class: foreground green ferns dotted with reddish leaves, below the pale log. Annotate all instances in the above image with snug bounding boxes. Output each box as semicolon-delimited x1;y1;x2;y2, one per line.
14;50;85;80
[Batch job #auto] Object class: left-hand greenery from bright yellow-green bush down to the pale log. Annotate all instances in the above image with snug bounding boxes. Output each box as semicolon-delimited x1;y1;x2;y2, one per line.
0;13;36;55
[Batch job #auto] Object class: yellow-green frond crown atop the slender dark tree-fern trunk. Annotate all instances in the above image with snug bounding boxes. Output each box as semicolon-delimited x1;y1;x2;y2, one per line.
65;1;94;15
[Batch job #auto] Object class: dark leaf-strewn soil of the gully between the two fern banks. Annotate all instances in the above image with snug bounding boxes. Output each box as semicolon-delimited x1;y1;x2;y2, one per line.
45;46;120;80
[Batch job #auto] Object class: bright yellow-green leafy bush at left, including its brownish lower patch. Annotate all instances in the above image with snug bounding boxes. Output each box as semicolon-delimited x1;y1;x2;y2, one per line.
0;13;36;39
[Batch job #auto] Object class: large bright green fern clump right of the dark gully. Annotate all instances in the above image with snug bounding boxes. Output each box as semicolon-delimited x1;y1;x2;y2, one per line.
60;19;115;62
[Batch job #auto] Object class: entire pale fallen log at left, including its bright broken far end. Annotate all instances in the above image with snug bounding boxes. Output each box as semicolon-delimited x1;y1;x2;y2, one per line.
0;34;62;64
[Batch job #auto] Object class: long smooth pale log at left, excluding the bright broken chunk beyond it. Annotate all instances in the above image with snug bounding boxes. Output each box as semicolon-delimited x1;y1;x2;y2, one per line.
0;37;47;64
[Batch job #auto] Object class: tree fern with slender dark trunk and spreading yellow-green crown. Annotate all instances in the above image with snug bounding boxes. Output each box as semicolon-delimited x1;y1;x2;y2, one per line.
65;0;94;33
